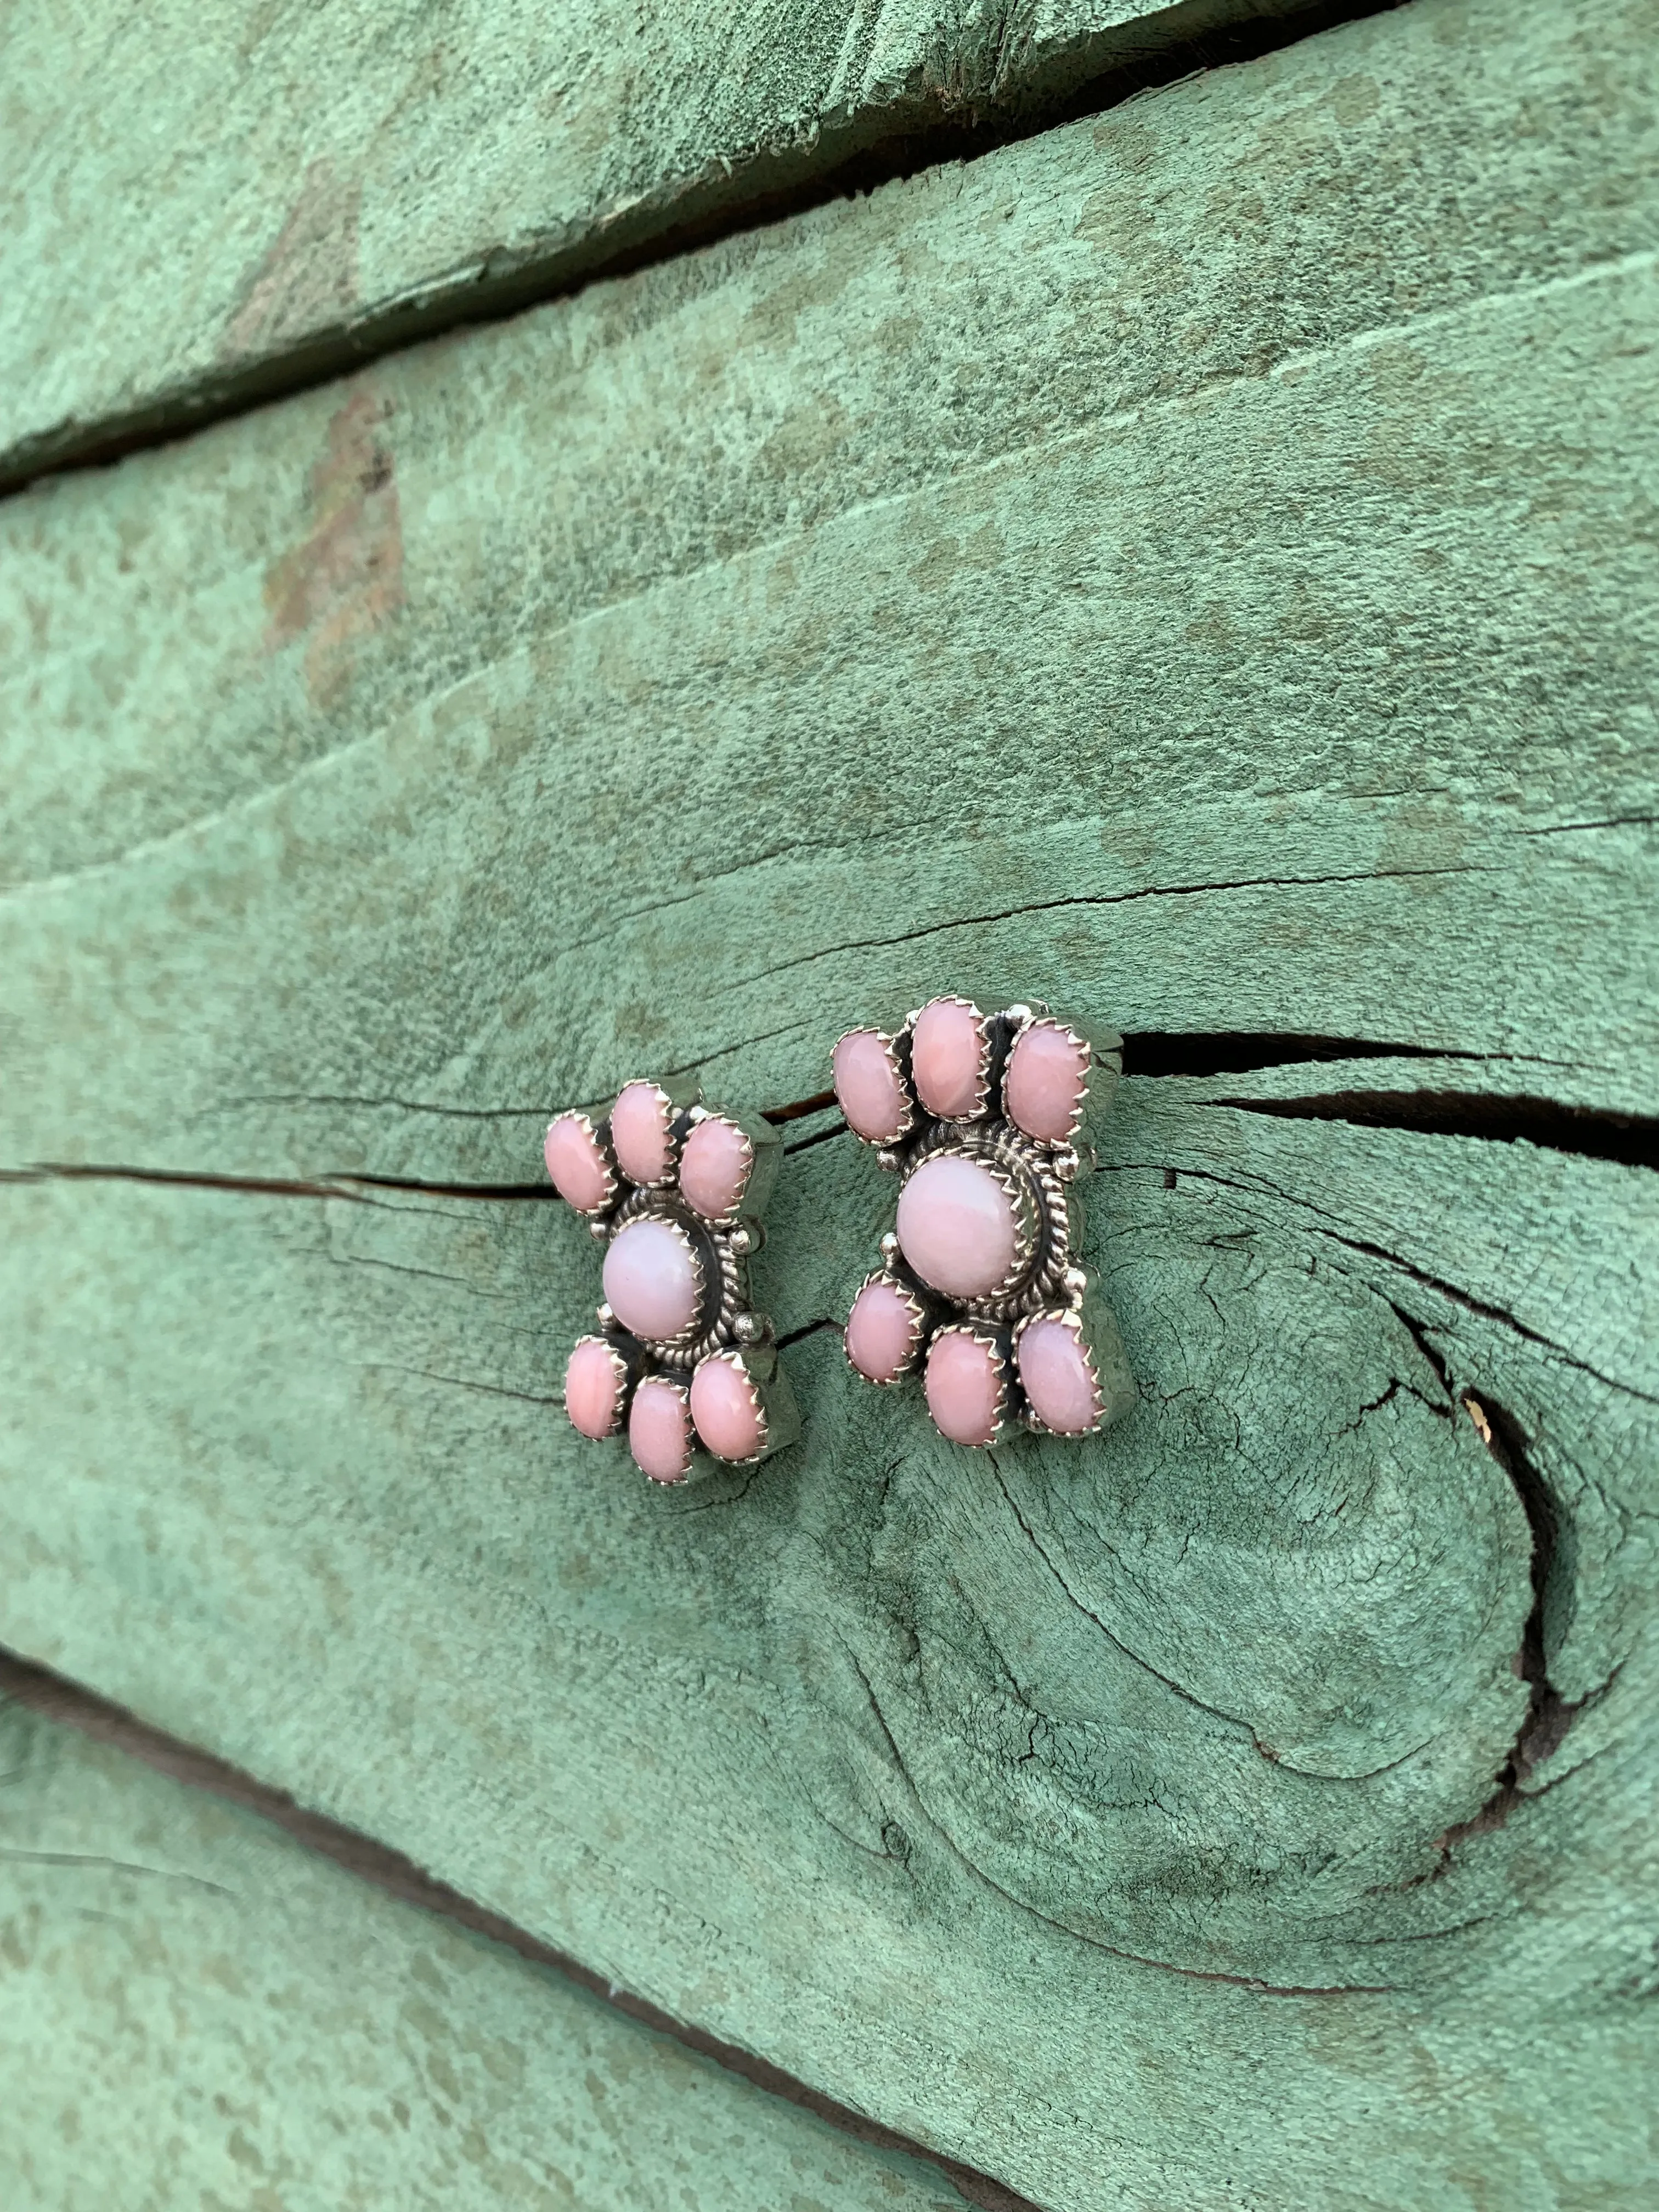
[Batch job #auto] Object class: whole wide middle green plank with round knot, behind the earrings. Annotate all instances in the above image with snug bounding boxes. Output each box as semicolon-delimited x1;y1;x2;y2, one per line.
0;0;1659;2212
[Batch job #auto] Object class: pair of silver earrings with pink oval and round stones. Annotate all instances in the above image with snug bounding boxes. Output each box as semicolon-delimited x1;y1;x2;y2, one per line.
546;997;1132;1482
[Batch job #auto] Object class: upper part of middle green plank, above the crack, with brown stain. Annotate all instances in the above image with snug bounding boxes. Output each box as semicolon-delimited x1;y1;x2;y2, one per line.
0;0;1659;1179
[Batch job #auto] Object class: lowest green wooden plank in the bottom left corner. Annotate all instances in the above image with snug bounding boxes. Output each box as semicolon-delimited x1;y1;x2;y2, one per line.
0;1706;986;2212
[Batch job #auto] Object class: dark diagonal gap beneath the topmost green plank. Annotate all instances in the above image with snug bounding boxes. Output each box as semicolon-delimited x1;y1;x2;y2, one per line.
0;0;1409;500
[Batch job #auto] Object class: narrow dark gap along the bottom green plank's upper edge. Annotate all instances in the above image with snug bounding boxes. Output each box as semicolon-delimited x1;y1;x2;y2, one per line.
0;1650;1042;2212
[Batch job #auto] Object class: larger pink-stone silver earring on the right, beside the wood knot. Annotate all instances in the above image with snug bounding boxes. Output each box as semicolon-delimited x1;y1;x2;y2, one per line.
834;997;1135;1444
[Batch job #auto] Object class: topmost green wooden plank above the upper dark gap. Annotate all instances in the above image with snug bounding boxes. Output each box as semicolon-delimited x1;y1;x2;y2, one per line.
0;0;1336;484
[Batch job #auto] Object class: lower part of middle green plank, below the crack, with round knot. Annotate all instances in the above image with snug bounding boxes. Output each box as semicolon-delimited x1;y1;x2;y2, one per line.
0;1070;1659;2208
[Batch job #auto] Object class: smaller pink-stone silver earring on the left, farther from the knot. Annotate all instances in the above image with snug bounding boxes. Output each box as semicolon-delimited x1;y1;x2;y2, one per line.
544;1082;801;1482
